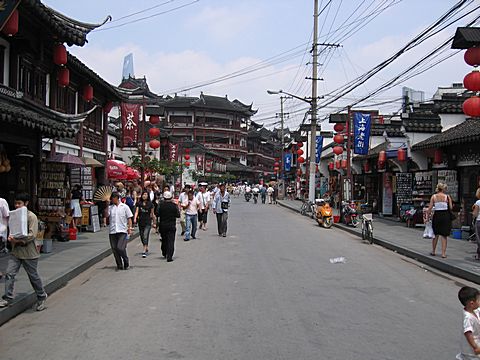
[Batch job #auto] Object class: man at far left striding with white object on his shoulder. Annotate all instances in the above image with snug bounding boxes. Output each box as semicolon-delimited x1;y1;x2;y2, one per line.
0;193;47;311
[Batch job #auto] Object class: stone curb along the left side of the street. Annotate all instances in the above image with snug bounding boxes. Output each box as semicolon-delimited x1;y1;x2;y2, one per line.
0;232;140;326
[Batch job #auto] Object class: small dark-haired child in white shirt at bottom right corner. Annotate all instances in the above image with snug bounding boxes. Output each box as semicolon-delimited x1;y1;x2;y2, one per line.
456;286;480;360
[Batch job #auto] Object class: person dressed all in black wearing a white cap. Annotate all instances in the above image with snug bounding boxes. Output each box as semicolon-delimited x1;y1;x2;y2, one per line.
157;191;180;262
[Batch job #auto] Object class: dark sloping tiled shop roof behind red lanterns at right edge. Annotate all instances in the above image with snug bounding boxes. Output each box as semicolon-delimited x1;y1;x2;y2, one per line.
412;118;480;150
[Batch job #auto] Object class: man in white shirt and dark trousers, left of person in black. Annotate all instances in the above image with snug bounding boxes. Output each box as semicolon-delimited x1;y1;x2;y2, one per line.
108;192;133;270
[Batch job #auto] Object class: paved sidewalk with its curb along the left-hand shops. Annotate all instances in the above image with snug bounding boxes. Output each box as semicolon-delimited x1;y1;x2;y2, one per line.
0;228;138;325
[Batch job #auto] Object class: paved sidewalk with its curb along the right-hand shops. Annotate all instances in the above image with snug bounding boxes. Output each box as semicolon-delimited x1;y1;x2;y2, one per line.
278;200;480;284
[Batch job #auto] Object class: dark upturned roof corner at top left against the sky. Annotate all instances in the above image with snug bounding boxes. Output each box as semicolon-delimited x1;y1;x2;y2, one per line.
20;0;112;46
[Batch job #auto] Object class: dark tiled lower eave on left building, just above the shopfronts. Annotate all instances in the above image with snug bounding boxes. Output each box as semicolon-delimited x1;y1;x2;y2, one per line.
0;97;75;138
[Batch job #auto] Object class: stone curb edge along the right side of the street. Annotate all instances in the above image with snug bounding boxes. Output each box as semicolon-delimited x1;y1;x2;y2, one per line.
278;203;480;284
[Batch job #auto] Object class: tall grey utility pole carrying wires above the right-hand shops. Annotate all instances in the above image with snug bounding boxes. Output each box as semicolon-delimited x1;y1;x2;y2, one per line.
308;0;318;202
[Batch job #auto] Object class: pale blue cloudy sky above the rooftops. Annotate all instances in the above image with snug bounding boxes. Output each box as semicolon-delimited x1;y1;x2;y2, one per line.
43;0;479;129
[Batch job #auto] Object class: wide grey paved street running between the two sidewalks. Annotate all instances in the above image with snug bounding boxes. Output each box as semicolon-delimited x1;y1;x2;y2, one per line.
0;199;469;360
